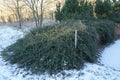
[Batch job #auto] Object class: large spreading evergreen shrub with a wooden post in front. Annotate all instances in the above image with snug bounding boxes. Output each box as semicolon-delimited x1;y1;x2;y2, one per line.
2;21;97;73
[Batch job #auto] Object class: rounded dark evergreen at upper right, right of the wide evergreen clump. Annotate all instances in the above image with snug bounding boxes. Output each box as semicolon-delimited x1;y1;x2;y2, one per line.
95;0;112;18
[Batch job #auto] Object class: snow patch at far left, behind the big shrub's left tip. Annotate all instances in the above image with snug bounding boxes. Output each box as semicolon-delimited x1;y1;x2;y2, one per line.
0;26;23;51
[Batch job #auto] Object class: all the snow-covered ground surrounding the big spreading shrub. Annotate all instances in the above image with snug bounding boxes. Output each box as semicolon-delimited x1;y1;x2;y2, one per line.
0;26;120;80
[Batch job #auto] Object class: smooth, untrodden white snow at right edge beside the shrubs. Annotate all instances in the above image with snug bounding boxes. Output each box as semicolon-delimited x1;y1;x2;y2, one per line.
101;40;120;70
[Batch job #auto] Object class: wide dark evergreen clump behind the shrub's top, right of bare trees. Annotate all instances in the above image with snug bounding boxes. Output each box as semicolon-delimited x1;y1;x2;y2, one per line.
55;0;93;21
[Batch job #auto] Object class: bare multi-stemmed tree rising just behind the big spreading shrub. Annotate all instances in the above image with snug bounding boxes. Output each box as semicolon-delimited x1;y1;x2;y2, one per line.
24;0;43;27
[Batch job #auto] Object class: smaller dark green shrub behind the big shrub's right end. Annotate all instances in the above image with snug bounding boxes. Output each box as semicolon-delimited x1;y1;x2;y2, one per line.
97;21;115;44
